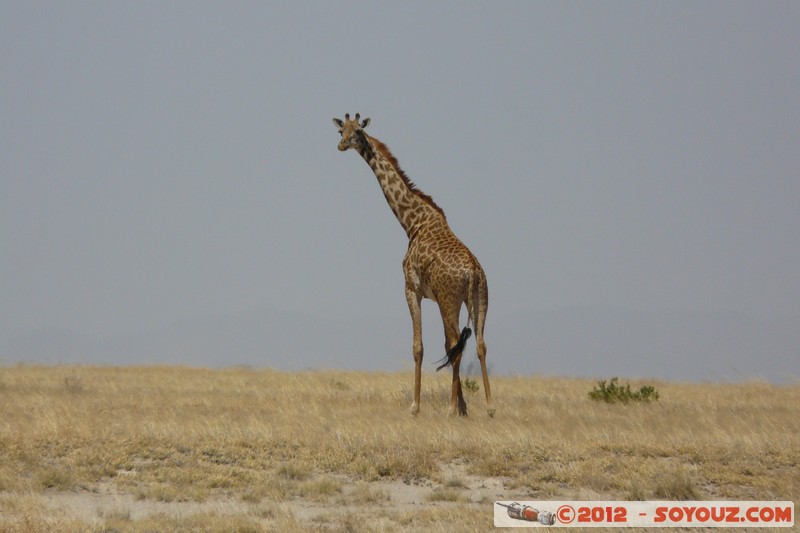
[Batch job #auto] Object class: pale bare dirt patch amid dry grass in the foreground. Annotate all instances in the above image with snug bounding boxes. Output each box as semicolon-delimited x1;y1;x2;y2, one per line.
30;463;510;530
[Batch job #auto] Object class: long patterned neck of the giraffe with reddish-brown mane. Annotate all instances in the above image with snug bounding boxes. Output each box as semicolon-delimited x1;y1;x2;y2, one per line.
358;131;445;239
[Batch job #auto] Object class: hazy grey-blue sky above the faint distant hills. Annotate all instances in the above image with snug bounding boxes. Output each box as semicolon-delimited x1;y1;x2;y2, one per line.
0;0;800;378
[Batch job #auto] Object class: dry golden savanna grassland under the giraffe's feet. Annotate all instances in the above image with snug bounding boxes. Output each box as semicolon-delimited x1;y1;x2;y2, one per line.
0;365;800;531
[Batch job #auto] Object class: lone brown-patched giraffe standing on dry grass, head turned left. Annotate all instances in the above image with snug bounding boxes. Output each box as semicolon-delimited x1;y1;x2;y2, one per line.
333;113;495;416
